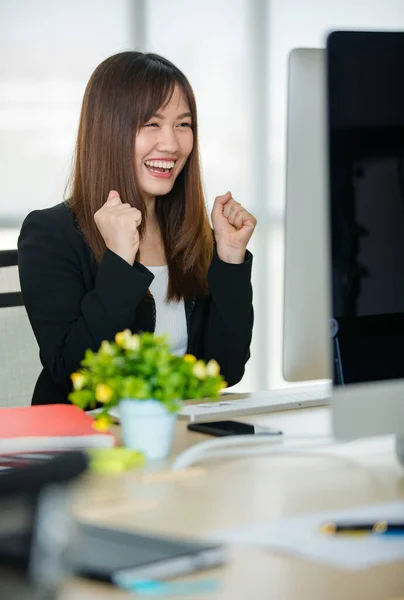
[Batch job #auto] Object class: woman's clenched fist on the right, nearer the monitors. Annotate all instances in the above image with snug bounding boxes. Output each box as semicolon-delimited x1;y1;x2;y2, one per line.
212;192;257;264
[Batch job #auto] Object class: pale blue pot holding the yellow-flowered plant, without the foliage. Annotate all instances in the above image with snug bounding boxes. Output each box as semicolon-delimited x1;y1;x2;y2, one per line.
119;398;177;460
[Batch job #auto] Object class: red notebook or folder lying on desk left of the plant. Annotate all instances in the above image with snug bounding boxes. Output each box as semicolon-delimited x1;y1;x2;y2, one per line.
0;404;115;454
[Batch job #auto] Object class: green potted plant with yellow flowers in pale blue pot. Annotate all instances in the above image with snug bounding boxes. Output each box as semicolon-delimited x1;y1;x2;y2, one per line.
69;329;226;459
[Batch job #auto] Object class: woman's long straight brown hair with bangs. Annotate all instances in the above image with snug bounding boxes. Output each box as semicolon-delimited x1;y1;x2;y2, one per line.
69;52;213;300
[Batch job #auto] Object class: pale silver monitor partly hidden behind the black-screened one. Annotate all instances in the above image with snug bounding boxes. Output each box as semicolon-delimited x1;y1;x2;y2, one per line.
283;48;332;381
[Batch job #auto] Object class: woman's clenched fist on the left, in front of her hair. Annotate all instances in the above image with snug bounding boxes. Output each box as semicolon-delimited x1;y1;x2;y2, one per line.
94;190;142;265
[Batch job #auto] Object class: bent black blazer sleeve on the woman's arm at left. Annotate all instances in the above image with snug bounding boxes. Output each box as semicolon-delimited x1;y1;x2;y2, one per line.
18;207;153;383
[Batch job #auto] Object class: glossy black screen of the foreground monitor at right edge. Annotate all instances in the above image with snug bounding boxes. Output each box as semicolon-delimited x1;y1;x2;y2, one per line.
327;32;404;383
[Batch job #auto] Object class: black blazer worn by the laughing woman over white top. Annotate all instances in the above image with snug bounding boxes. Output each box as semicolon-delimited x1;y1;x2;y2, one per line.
18;203;253;404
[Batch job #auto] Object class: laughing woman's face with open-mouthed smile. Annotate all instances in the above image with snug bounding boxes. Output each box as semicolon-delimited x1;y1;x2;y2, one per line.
135;85;194;201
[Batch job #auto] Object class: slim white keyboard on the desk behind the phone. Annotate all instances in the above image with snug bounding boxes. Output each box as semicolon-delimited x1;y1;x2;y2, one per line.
178;383;331;423
